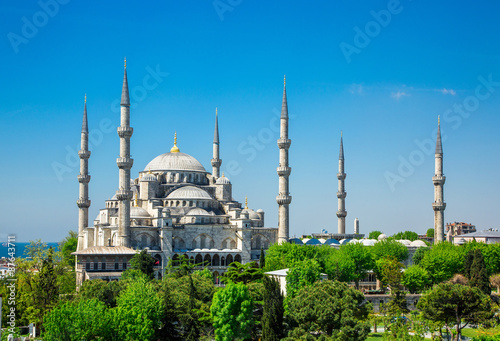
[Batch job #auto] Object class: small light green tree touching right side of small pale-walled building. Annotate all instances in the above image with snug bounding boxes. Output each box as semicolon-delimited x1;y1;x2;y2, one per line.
286;259;321;299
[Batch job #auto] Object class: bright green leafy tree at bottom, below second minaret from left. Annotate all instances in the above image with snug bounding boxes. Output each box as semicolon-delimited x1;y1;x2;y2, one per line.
110;277;165;340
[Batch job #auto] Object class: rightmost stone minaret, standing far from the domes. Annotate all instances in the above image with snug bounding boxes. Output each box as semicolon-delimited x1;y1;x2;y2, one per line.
432;116;446;243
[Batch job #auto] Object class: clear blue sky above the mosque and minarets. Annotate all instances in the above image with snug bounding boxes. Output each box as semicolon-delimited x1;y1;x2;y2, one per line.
0;0;500;241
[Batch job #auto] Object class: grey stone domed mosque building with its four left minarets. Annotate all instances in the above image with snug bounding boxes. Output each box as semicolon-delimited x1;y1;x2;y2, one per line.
74;64;291;286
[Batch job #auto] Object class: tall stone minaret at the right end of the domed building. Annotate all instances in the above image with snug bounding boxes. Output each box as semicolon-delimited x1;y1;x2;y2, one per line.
276;77;292;243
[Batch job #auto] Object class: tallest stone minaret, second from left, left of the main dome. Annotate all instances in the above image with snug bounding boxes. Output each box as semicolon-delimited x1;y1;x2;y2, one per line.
116;59;134;247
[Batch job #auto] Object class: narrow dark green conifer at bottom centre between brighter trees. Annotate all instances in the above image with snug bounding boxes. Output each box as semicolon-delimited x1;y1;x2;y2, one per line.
262;276;284;341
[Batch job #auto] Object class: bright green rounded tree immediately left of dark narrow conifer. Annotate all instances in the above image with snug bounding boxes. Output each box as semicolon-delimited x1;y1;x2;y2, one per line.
210;283;253;341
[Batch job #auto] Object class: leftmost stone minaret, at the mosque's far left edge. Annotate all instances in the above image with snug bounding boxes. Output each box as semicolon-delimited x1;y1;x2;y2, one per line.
76;95;90;250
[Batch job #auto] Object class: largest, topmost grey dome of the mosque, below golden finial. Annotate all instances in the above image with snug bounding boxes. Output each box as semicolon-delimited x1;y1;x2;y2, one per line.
144;152;206;173
